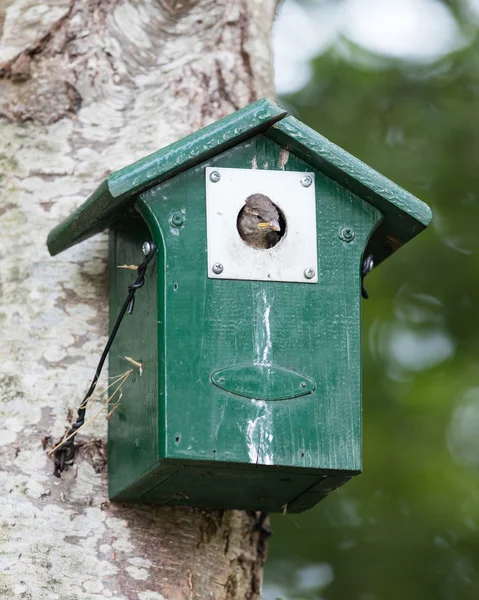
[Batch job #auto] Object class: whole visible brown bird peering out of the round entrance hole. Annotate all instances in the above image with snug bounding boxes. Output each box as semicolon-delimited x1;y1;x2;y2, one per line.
237;194;282;248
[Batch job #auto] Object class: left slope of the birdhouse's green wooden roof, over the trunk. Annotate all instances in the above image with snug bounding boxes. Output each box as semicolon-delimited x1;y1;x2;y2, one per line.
47;98;286;255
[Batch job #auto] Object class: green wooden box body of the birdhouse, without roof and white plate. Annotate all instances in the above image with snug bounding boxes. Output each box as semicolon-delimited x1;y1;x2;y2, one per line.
109;135;381;511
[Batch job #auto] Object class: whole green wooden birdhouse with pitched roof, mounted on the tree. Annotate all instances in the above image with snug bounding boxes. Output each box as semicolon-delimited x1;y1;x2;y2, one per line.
48;100;431;512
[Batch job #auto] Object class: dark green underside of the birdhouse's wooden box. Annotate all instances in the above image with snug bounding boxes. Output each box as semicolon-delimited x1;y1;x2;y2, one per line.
110;459;360;513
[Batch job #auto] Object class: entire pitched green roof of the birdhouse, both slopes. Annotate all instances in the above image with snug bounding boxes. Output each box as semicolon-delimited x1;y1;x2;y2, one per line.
47;99;432;264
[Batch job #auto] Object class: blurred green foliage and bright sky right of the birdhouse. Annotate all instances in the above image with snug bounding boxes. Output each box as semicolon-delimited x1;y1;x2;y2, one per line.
263;0;479;600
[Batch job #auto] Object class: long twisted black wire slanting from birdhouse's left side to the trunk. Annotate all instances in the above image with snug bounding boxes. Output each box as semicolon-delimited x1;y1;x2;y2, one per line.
53;242;156;477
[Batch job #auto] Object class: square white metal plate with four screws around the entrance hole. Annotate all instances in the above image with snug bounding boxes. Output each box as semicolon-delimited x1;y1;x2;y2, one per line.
206;167;318;283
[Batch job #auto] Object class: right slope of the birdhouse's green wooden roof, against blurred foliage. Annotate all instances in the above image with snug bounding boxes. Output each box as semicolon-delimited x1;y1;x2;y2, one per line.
266;116;432;264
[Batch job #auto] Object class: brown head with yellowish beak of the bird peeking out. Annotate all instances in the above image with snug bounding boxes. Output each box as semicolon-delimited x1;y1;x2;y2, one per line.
238;194;281;245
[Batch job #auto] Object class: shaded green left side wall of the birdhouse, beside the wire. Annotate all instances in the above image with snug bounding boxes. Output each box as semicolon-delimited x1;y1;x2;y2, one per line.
108;214;159;497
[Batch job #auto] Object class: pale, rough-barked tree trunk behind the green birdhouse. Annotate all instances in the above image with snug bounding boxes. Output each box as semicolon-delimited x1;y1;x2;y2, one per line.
0;0;276;600
